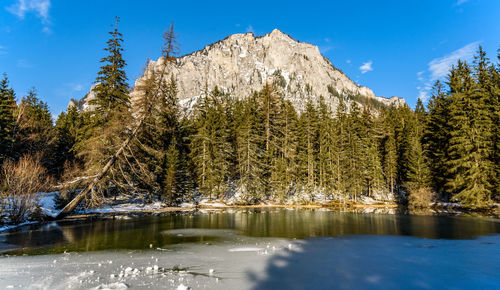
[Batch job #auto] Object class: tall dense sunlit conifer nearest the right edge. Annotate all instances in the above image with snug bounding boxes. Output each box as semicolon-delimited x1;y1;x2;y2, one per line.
447;59;494;208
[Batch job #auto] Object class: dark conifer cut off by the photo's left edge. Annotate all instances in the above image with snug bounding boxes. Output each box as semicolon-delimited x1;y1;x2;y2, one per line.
0;74;16;165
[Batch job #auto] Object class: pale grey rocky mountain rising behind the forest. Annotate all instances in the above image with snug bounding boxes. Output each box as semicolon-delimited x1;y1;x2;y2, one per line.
74;29;405;111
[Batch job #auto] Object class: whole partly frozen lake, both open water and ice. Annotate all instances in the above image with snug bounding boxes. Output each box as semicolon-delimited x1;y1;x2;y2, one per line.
0;209;500;289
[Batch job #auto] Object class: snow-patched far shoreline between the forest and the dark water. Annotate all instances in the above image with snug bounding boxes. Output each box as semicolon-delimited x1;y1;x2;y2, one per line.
0;192;496;232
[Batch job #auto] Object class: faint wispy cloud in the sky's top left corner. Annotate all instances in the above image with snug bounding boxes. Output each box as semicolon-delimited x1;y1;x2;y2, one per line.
5;0;52;33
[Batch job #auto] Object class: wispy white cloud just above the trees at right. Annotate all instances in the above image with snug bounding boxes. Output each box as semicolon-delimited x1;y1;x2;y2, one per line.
417;41;479;102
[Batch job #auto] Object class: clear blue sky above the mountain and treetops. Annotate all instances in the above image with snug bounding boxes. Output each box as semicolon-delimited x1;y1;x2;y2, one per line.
0;0;500;114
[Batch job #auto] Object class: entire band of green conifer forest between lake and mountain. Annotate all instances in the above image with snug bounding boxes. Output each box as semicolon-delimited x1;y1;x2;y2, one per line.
0;21;500;222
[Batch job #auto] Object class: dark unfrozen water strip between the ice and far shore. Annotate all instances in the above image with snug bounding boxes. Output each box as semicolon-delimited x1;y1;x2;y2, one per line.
0;209;500;258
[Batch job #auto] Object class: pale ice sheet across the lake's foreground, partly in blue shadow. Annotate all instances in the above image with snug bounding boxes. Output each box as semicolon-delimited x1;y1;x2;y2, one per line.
0;230;500;289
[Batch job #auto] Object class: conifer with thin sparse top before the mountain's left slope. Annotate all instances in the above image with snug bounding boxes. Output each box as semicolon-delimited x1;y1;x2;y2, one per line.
129;24;188;205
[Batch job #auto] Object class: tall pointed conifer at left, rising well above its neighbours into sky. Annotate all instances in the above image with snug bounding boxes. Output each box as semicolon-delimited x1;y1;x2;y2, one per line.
75;17;132;206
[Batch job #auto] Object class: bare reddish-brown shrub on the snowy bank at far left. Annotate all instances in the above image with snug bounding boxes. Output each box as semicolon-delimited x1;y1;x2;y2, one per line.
0;155;51;223
